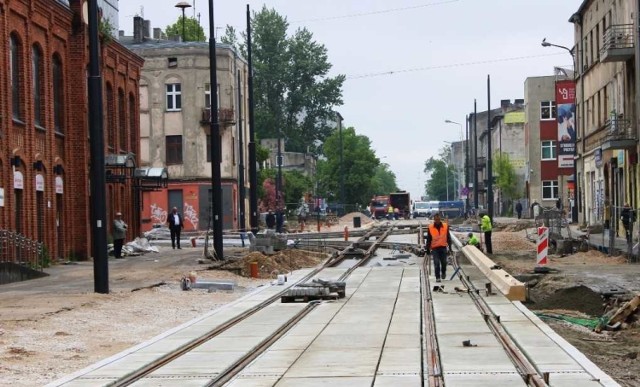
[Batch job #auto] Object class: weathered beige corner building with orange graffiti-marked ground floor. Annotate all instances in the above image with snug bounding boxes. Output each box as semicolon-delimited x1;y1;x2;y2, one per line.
126;39;249;230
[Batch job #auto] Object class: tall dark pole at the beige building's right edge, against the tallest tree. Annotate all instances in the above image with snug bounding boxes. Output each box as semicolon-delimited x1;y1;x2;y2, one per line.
247;4;258;234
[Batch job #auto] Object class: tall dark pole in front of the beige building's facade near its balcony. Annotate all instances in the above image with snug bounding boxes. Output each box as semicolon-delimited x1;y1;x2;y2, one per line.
209;0;224;259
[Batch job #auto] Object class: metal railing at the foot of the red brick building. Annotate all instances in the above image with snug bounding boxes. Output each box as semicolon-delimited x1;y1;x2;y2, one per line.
0;230;48;271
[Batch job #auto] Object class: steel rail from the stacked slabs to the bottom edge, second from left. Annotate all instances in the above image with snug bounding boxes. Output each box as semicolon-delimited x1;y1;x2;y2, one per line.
205;301;320;387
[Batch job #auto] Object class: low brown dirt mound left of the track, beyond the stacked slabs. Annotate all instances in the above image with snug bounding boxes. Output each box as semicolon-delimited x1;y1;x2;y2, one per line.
210;249;328;278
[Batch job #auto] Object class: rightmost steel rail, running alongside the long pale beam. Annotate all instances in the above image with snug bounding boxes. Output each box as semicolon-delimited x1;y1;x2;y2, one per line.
452;246;548;387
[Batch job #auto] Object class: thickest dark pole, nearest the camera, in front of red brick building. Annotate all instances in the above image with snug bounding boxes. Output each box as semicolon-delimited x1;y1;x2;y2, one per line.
89;0;109;294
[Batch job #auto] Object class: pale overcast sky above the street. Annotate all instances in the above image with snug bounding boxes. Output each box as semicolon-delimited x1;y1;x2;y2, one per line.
119;0;582;203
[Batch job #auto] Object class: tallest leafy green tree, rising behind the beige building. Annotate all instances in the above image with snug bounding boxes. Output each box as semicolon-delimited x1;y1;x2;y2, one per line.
221;6;345;153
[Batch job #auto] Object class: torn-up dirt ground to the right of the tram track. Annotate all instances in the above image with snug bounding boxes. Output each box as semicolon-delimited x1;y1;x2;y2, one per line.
484;230;640;386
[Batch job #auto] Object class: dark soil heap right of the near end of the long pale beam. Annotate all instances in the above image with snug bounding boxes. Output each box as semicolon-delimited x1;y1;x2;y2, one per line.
529;285;604;317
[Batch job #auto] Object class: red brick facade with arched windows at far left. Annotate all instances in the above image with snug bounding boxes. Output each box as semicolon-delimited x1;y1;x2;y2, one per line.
0;0;143;259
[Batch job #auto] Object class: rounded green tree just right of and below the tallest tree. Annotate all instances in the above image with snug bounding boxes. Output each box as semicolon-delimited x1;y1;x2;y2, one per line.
317;128;380;204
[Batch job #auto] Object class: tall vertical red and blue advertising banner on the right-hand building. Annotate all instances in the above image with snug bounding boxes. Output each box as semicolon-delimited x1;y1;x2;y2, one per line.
556;81;576;168
